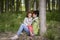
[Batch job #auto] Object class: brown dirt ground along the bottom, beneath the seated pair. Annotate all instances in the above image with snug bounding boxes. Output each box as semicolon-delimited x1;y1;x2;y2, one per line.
0;32;40;40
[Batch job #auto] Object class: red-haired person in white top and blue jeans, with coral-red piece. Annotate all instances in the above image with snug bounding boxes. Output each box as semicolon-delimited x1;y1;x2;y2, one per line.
11;12;33;40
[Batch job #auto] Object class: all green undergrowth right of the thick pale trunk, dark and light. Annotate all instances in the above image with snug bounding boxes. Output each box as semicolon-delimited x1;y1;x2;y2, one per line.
45;11;60;40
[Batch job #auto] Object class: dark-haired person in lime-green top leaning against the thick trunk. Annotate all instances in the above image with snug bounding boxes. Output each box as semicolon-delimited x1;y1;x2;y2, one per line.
32;11;39;35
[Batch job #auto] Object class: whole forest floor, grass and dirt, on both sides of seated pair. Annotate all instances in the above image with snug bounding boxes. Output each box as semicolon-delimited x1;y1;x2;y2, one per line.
0;11;60;40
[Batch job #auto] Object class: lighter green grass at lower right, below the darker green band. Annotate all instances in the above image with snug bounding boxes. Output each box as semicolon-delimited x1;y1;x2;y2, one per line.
45;21;60;40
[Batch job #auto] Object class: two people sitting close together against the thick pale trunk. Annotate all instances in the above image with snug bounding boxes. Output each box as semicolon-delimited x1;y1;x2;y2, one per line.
11;11;39;39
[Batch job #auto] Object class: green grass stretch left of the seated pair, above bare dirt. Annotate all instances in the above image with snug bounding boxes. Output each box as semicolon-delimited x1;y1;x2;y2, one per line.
0;12;26;32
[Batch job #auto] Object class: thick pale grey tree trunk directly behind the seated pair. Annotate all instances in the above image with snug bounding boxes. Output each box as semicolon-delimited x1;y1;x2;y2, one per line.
39;0;46;36
